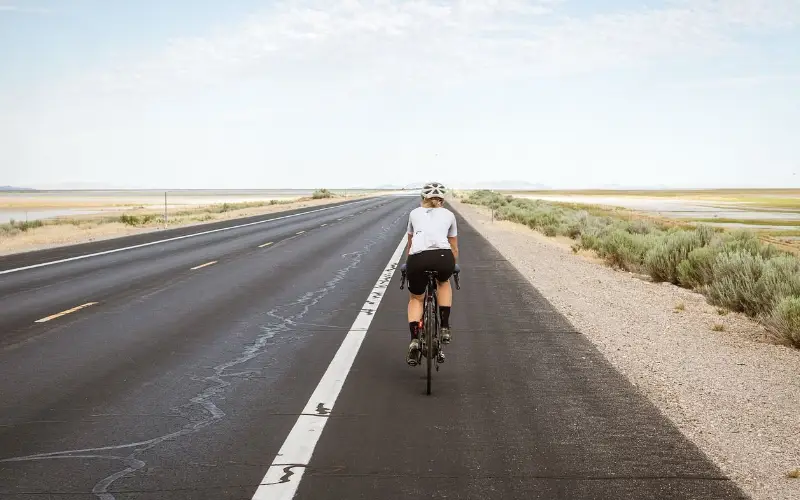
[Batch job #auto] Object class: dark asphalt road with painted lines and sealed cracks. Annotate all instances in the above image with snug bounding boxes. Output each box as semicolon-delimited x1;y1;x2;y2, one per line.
0;197;745;500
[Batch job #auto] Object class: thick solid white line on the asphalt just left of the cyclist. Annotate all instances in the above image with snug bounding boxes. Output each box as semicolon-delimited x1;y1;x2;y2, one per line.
253;237;406;500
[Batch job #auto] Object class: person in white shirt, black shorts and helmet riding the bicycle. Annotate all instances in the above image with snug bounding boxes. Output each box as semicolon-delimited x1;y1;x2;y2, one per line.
406;182;458;366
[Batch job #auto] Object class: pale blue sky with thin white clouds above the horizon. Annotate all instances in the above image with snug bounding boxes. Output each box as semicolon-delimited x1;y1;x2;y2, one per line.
0;0;800;189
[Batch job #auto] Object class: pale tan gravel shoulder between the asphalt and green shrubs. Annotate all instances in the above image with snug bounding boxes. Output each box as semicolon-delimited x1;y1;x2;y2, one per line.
452;201;800;500
